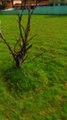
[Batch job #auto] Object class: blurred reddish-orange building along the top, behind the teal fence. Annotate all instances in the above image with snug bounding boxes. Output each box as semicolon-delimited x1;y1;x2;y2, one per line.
0;0;67;8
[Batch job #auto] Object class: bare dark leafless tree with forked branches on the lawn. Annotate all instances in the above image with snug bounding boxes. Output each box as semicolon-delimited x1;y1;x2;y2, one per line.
0;0;35;68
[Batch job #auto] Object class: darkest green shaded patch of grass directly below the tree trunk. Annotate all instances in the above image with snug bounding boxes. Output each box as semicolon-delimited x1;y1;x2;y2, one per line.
5;68;30;94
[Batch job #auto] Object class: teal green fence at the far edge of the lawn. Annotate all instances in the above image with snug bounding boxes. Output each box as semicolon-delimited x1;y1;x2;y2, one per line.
0;6;67;15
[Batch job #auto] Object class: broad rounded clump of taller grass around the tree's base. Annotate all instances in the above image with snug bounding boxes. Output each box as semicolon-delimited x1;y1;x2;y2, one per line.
4;64;41;96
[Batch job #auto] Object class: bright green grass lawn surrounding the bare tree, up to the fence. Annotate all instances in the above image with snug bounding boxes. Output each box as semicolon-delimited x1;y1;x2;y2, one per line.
0;15;67;120
